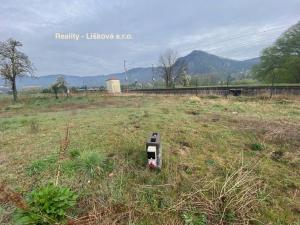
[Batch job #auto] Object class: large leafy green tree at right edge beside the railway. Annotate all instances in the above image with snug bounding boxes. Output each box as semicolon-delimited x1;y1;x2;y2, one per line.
252;22;300;83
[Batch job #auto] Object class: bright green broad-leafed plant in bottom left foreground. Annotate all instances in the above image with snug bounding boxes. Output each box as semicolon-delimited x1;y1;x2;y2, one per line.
15;184;78;225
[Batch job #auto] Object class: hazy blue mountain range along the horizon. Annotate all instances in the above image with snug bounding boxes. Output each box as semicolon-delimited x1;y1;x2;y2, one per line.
0;50;259;89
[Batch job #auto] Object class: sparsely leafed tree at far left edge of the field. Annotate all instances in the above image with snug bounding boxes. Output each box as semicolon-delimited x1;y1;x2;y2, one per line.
0;38;34;101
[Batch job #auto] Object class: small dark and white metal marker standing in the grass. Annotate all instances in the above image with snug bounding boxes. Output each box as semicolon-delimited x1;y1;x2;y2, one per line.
146;132;162;169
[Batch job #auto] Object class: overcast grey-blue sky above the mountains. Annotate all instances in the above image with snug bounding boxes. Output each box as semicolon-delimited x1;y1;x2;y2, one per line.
0;0;300;76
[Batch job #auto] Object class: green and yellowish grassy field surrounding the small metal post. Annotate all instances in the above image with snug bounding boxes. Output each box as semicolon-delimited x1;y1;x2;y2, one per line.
0;92;300;225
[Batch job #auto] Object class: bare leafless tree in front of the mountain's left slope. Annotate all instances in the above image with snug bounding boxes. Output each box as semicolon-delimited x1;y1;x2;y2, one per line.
158;49;186;87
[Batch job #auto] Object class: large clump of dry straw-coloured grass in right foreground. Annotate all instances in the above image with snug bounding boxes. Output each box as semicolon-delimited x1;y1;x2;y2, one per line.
170;165;263;225
